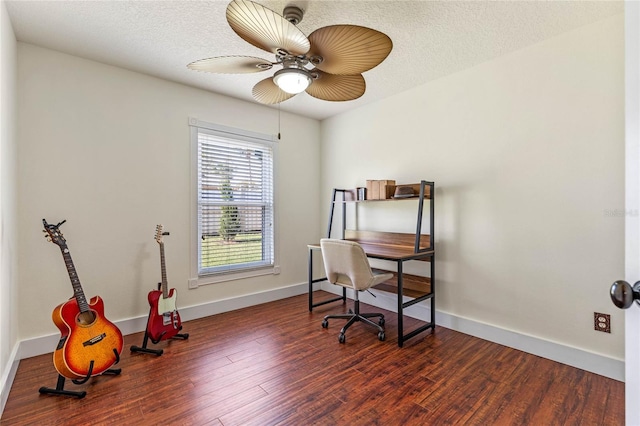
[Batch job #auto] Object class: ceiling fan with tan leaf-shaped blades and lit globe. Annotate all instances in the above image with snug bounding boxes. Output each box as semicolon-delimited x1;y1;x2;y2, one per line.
187;0;393;104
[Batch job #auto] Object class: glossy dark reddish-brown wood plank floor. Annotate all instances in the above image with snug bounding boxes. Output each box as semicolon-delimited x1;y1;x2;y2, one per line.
0;292;624;426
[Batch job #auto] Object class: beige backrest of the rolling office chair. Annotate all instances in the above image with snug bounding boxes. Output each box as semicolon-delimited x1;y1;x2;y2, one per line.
320;238;380;290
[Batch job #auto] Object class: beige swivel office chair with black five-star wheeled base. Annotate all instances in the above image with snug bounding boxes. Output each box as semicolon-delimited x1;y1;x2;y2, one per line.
320;238;393;343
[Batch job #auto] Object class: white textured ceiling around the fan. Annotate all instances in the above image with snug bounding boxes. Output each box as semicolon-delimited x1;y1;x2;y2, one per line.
6;0;624;119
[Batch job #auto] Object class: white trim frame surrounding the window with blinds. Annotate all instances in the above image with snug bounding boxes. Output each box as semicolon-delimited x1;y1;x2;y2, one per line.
188;117;280;288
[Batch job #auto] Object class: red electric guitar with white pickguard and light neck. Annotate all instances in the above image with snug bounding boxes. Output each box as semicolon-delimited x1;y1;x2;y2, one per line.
147;225;182;343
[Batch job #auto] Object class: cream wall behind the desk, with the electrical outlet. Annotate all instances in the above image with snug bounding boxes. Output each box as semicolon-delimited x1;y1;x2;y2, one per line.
321;15;625;360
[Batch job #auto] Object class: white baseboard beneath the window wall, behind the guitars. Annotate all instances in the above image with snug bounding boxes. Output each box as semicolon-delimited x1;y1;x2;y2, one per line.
16;283;308;362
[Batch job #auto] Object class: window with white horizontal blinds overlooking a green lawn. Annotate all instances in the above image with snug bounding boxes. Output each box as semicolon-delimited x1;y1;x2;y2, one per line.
191;119;274;276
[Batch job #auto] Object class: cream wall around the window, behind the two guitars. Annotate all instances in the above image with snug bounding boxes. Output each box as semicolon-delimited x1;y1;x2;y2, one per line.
18;43;320;342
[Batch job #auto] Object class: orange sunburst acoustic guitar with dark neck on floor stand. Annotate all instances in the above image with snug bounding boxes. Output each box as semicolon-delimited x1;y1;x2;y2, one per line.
42;219;124;380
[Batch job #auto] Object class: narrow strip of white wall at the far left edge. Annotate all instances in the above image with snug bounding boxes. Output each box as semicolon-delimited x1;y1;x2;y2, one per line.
0;1;18;413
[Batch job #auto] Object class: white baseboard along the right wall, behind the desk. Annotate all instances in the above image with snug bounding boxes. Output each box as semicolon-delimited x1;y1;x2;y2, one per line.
320;282;625;382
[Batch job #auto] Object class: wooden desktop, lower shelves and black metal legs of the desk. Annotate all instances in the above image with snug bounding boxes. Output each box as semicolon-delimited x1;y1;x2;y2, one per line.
307;235;436;347
